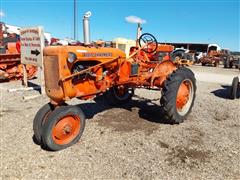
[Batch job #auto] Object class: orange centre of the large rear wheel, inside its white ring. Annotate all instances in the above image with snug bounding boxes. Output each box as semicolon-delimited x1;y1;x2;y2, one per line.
176;81;191;111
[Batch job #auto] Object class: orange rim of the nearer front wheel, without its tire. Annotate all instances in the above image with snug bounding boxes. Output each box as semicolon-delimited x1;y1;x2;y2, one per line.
52;115;81;145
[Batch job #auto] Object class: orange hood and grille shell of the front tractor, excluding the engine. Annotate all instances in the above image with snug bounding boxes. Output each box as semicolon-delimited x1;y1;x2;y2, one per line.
43;46;126;102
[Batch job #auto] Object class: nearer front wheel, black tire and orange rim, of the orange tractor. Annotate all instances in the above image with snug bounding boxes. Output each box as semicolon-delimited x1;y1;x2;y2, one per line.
42;106;85;151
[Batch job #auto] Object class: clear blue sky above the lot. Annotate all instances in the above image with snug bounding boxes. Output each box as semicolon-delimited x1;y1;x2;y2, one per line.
0;0;240;50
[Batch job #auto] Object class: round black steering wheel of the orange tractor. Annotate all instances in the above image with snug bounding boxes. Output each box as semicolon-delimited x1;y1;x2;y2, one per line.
139;33;158;53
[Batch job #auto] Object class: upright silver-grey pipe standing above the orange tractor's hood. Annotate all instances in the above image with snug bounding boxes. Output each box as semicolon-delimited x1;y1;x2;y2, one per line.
83;11;92;45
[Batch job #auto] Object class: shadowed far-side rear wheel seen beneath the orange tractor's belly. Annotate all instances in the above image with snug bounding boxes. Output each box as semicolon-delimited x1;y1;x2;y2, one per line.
104;86;134;106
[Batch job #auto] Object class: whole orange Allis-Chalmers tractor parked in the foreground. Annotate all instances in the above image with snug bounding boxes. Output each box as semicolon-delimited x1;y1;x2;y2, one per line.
33;13;196;151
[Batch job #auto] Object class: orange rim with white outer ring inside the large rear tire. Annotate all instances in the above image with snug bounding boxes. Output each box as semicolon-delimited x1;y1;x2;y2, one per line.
176;80;193;116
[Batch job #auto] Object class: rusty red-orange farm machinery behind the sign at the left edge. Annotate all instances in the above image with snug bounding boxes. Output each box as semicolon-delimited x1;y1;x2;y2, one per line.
0;23;37;82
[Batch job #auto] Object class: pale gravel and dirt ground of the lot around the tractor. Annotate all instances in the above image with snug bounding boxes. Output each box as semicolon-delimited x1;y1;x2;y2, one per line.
0;66;240;179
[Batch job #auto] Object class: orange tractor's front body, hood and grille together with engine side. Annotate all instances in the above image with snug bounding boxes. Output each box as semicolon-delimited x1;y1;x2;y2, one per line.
44;46;125;102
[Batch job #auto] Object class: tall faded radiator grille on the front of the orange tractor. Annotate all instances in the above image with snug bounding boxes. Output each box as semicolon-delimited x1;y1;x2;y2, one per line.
44;56;60;92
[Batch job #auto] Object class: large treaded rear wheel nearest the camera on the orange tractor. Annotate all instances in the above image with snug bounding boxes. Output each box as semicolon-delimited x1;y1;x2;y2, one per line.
160;67;196;124
